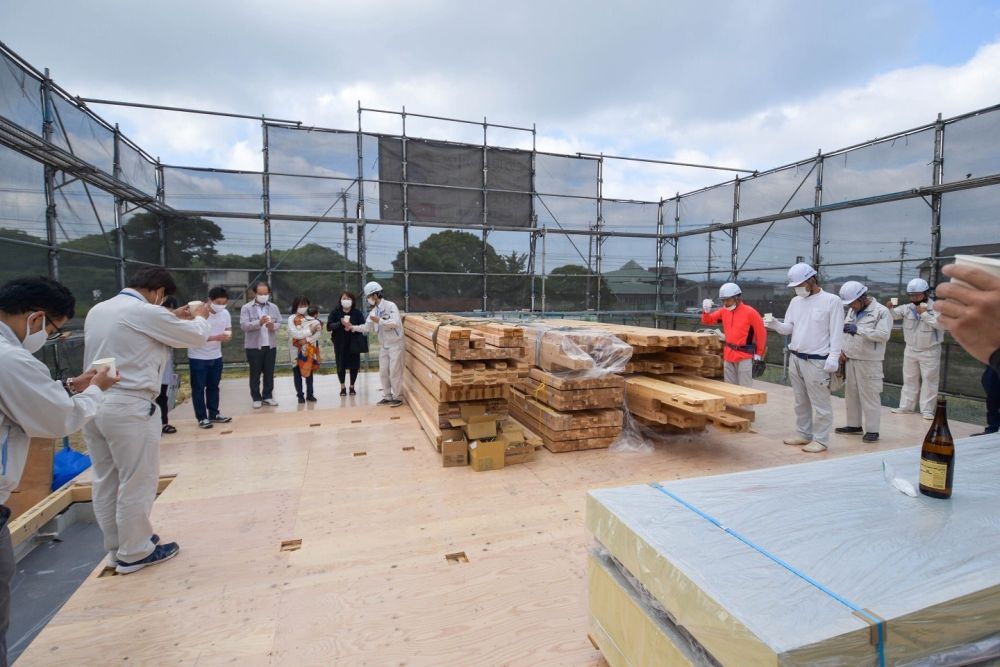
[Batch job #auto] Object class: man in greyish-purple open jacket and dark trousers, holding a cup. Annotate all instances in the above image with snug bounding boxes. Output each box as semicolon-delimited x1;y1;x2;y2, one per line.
240;280;281;410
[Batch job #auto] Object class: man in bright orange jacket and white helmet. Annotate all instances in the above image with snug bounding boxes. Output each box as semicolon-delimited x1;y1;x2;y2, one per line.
701;283;767;387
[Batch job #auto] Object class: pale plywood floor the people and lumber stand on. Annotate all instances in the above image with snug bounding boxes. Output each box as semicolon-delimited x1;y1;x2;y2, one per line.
14;375;979;666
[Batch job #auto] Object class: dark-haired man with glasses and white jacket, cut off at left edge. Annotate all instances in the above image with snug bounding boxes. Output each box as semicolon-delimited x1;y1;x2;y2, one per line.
0;277;118;666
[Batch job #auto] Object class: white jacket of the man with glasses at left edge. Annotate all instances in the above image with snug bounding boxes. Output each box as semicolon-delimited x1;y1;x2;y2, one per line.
0;322;104;503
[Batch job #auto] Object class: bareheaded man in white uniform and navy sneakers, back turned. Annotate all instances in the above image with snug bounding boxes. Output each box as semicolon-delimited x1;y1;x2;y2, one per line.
83;267;211;574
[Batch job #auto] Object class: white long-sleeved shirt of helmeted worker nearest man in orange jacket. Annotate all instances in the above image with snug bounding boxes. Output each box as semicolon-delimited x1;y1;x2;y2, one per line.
771;290;844;359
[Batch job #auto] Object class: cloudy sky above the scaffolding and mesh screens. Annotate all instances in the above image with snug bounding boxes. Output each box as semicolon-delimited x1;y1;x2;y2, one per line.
0;0;1000;276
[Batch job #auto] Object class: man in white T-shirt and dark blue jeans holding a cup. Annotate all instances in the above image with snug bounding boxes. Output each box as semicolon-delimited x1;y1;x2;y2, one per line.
188;287;233;428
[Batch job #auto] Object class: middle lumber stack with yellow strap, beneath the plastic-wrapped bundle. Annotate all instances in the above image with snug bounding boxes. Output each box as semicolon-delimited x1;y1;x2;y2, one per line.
509;368;625;452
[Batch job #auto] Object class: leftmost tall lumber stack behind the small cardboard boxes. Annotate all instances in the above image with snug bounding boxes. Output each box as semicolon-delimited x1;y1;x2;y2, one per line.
403;314;528;451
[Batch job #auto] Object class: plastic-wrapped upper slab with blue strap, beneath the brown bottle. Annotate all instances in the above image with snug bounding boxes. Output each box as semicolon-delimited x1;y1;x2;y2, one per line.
587;435;1000;667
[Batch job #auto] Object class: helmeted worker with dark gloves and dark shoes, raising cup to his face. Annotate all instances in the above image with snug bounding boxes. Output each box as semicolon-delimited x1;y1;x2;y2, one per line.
836;280;892;442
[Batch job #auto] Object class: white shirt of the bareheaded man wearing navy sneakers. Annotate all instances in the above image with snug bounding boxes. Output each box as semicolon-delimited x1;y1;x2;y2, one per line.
83;288;208;400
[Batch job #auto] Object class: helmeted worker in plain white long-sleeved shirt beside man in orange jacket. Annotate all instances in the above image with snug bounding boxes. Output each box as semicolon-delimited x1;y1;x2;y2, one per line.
764;263;844;453
